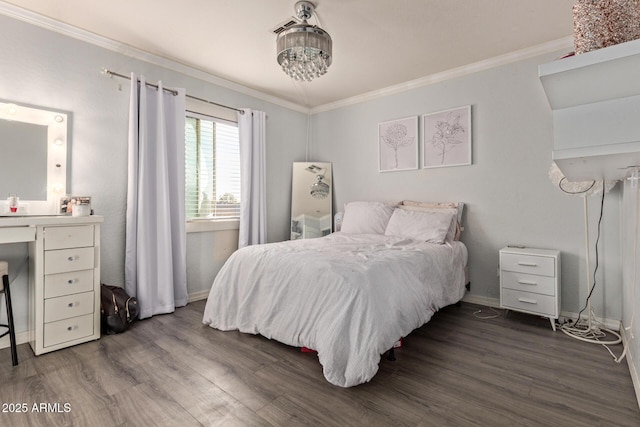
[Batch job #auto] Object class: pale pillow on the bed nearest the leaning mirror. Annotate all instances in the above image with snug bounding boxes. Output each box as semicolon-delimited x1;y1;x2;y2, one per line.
340;202;394;234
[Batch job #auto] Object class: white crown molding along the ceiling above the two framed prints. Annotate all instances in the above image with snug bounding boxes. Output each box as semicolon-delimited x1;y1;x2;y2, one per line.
310;36;573;114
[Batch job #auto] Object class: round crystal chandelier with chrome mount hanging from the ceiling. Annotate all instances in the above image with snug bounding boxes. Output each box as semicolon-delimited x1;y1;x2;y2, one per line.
276;1;332;82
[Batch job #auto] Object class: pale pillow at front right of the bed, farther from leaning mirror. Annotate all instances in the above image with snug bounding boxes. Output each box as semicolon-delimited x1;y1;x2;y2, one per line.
384;209;455;244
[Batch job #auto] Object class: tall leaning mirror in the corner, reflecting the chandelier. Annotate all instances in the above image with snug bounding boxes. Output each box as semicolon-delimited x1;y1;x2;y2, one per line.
291;162;333;240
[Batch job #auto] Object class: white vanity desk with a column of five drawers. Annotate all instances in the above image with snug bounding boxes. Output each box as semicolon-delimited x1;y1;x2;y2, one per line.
0;215;104;355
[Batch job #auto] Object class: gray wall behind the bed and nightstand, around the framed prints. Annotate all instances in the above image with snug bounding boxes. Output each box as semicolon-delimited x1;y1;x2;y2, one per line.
312;53;621;320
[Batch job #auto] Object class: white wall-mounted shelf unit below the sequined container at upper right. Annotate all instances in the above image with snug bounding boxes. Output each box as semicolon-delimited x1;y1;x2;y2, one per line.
539;40;640;181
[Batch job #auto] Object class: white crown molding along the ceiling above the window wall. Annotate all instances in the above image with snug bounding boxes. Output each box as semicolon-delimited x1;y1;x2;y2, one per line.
0;1;309;114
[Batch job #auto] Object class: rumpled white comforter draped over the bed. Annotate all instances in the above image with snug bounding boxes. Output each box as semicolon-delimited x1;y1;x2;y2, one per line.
203;233;467;387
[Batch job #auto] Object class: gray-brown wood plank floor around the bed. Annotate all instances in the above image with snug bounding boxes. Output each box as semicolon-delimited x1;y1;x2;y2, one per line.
0;301;640;427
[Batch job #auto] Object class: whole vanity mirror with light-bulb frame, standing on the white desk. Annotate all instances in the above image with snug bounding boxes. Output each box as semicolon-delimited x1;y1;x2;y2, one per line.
0;102;68;216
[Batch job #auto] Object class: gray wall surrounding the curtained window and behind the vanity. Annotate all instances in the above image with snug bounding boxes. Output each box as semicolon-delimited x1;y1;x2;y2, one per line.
0;15;307;332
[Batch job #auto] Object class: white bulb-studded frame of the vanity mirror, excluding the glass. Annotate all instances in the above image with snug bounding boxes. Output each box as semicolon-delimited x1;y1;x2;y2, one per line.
0;102;69;216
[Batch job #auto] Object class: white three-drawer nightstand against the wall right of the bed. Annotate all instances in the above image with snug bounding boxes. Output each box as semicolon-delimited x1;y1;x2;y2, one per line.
500;247;560;331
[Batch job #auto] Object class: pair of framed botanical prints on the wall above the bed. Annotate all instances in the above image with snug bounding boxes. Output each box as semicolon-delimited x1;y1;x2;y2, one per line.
378;105;471;172
